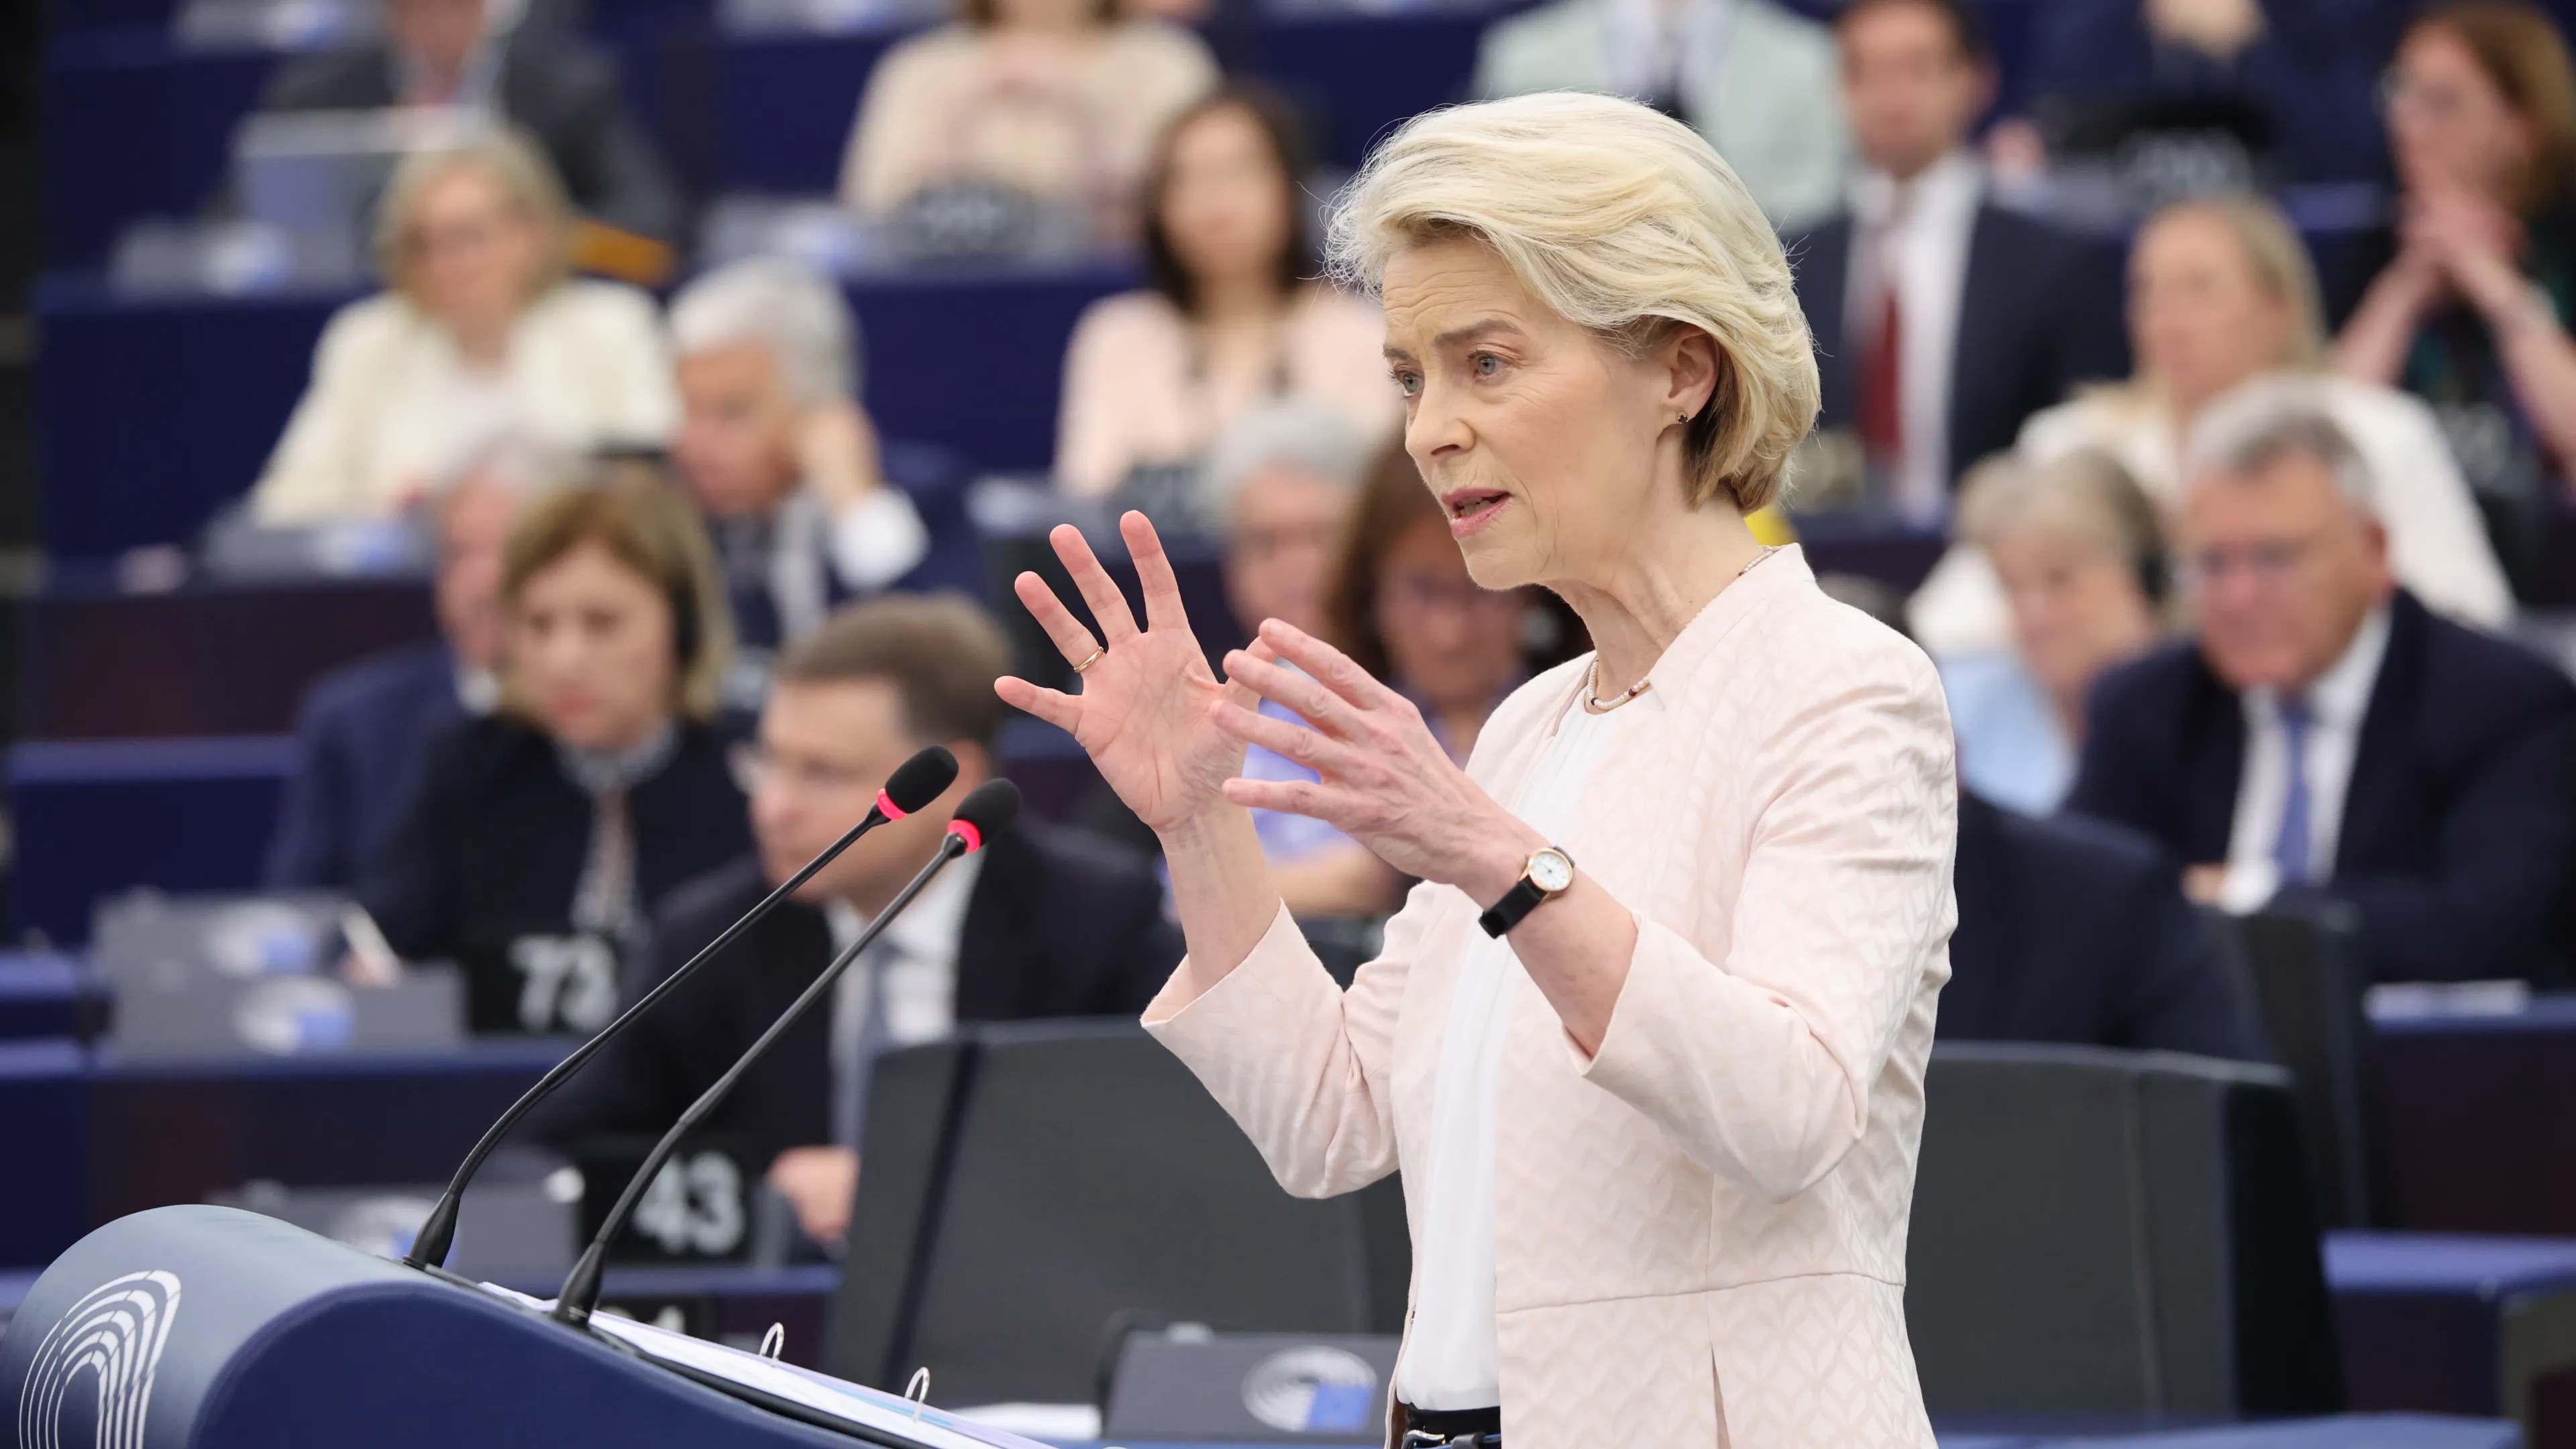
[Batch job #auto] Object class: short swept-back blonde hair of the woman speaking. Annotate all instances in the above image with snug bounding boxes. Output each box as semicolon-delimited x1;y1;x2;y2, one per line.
1332;93;1819;513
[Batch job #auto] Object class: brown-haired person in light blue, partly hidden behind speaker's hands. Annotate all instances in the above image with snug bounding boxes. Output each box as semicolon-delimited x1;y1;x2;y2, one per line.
1239;443;1589;915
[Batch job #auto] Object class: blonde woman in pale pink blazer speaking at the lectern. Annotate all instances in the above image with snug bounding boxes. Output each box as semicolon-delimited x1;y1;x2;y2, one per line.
1000;93;1955;1449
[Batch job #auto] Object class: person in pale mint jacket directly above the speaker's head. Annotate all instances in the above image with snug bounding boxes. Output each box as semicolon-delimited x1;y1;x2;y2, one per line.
1473;0;1849;227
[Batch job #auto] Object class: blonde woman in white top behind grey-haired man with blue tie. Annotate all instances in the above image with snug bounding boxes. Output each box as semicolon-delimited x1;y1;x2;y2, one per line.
1909;196;2514;655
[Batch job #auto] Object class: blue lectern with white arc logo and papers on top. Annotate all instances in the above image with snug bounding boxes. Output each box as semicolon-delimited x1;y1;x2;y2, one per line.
0;1207;1043;1449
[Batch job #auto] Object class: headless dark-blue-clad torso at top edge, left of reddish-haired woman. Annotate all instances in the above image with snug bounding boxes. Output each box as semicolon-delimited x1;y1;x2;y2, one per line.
2030;0;2396;180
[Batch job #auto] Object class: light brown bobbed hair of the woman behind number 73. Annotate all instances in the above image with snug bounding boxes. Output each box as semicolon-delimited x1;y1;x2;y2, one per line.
500;462;734;719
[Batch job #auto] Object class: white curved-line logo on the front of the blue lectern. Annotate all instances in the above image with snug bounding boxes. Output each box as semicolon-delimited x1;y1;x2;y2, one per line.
18;1269;178;1449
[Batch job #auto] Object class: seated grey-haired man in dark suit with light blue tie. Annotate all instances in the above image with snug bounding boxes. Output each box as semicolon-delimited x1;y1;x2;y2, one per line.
2066;392;2576;985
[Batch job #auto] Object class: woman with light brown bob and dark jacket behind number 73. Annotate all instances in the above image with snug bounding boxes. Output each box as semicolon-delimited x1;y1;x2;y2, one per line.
358;464;749;1031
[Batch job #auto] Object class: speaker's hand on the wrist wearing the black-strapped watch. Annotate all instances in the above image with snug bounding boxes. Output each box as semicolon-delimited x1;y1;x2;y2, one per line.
1214;619;1548;905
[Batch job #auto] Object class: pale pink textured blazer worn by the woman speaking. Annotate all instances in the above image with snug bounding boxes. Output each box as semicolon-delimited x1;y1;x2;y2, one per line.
1146;549;1955;1449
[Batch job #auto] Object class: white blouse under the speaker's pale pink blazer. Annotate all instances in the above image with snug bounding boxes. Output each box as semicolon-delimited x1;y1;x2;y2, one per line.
1396;691;1664;1410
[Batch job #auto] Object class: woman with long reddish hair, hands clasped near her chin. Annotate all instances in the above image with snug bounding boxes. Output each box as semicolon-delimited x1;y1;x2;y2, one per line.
2334;0;2576;511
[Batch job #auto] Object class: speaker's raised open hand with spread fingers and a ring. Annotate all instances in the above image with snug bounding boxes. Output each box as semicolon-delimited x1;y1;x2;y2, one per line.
994;513;1260;833
